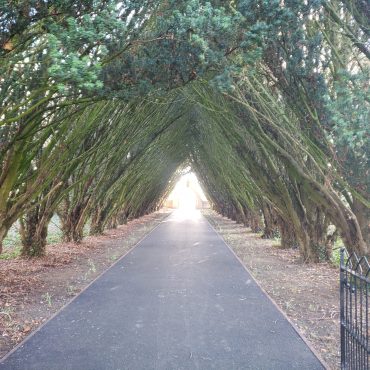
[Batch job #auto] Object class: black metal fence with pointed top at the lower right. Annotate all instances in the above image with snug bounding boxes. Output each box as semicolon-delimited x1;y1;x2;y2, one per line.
340;249;370;370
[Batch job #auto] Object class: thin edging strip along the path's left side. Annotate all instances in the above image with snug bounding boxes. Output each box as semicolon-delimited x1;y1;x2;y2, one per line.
0;212;171;367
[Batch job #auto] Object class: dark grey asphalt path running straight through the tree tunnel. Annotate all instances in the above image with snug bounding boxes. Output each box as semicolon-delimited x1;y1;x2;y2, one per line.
0;211;323;370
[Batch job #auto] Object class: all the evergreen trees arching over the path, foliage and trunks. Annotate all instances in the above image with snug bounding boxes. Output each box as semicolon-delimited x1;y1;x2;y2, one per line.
0;0;370;261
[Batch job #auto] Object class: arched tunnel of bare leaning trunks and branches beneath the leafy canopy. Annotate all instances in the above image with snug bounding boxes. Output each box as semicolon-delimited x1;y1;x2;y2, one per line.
0;80;366;261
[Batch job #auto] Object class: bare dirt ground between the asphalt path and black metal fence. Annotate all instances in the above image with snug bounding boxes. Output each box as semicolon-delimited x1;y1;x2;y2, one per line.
205;211;340;369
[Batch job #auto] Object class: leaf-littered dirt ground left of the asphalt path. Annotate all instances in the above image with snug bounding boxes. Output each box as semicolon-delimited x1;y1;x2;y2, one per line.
0;210;170;358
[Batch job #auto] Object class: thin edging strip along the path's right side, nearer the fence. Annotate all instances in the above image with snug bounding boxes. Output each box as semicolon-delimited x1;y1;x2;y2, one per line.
203;214;333;370
